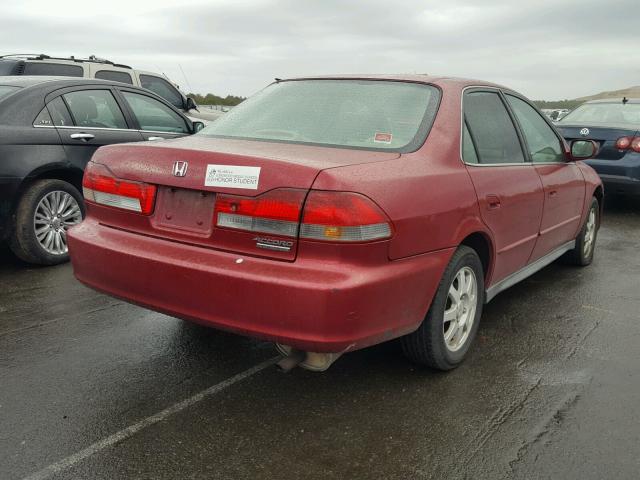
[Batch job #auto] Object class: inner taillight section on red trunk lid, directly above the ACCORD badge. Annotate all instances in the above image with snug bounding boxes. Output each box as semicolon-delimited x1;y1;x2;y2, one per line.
215;188;305;237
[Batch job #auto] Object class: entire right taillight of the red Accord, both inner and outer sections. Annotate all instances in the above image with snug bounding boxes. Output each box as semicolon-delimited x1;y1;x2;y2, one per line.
215;189;391;242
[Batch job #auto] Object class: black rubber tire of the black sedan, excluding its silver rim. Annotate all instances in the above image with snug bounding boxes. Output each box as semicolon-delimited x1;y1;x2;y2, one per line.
9;179;85;265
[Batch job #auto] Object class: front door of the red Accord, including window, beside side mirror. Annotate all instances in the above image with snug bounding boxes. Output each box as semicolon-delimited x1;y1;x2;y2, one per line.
505;94;586;260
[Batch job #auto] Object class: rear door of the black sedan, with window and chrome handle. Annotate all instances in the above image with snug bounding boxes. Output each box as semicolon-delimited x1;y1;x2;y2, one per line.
47;85;143;168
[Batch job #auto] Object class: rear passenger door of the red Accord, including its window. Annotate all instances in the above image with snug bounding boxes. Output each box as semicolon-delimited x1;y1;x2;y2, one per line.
463;88;544;284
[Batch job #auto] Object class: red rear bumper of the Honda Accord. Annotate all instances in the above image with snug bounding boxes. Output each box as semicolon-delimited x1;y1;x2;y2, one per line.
68;219;453;352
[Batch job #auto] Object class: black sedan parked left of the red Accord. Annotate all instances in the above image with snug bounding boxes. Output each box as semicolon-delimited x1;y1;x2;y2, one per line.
0;76;204;265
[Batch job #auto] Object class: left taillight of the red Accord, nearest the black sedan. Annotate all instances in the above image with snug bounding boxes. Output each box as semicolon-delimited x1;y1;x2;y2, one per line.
82;162;156;215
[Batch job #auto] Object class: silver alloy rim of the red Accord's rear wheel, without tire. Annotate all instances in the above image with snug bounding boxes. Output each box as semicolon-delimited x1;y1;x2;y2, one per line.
442;267;478;352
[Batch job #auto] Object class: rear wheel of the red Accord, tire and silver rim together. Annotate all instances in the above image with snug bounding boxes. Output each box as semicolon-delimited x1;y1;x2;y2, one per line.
402;246;484;370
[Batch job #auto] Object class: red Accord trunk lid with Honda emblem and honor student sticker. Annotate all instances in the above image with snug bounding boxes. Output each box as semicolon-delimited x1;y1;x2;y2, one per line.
92;137;399;261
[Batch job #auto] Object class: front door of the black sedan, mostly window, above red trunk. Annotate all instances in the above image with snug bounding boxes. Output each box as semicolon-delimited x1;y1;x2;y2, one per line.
118;88;193;140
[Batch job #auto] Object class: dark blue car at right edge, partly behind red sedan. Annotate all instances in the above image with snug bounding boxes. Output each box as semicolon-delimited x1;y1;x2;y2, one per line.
556;98;640;195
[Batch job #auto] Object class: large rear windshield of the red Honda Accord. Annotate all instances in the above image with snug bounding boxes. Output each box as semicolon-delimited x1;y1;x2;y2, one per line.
198;80;440;152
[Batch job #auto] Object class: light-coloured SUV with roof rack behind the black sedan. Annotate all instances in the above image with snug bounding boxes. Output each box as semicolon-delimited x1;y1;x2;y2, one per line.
0;54;221;122
